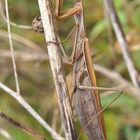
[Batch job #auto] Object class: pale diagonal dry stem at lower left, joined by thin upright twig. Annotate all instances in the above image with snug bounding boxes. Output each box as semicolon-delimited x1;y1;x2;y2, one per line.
0;82;64;140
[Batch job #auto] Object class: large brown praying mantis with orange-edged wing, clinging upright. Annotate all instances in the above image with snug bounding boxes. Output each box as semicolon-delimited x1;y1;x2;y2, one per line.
33;0;122;140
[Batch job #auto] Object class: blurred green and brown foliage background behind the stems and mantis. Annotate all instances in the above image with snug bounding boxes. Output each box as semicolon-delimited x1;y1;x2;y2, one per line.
0;0;140;140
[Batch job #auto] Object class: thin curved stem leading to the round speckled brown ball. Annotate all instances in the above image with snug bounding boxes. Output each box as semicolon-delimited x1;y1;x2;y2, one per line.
0;0;32;30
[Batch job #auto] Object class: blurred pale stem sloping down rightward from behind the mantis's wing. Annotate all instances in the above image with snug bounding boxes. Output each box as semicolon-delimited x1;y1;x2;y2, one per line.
94;64;140;101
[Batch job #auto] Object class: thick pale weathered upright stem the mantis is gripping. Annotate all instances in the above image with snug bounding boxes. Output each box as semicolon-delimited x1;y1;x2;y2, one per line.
38;0;77;140
